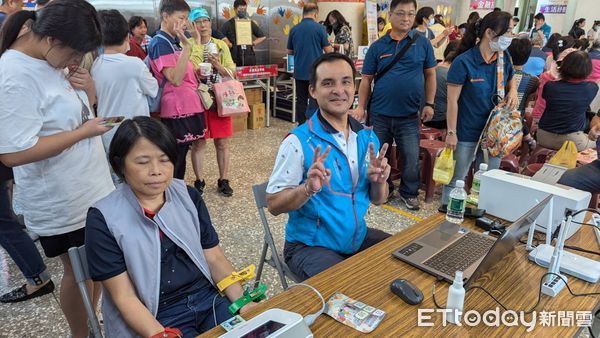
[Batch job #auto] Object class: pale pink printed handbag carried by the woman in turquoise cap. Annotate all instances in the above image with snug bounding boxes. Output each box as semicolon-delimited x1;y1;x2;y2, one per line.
213;68;250;117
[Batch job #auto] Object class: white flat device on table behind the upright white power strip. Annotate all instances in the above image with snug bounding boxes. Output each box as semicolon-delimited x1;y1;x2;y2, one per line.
529;244;600;283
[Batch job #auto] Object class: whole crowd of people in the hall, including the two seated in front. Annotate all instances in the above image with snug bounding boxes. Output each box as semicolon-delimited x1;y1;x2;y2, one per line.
0;0;600;337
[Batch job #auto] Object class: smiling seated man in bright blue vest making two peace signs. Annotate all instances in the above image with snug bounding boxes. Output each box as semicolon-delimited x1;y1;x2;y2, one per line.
267;53;390;279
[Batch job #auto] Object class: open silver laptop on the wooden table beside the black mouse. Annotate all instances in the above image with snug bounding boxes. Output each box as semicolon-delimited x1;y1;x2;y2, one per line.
392;195;552;285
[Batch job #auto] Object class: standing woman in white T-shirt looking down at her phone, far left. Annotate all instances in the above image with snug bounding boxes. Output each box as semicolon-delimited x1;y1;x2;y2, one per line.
0;0;114;338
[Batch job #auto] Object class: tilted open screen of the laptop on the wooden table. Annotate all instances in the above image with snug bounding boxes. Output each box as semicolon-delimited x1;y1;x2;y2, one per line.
465;195;552;286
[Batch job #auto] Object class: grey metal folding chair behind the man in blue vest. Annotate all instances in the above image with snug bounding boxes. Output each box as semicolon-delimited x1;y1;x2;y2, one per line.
252;182;301;290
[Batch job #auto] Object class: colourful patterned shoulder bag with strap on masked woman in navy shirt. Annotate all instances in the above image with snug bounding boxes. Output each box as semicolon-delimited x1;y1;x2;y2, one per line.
475;51;523;163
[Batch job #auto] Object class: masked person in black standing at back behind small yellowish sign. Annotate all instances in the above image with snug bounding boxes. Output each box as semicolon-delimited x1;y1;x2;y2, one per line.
221;0;267;67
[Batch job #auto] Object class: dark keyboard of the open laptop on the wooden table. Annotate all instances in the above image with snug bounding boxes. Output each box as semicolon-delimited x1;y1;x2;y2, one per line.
423;232;496;276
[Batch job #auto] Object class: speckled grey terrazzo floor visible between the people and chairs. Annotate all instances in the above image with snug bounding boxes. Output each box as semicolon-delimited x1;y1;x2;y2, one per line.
0;119;452;337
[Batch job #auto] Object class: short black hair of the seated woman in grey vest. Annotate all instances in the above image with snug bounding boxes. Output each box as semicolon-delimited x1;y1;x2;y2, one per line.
108;116;177;179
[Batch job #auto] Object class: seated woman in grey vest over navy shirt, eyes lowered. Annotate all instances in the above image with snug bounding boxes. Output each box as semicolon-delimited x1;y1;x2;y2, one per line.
86;116;254;338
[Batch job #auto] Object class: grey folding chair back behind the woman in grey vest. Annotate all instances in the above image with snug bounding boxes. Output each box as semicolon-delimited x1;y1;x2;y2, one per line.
69;245;103;338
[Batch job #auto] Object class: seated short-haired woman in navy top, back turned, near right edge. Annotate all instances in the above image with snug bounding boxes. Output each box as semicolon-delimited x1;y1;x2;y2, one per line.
537;51;598;151
